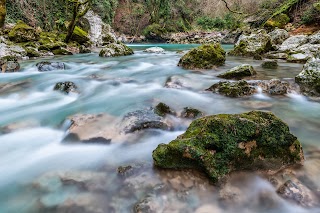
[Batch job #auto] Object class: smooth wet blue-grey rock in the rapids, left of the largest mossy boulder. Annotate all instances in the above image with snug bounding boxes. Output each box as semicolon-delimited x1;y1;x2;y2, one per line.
121;109;170;134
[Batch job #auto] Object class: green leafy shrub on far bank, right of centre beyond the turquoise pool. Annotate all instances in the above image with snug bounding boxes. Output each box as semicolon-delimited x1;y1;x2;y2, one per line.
197;13;240;30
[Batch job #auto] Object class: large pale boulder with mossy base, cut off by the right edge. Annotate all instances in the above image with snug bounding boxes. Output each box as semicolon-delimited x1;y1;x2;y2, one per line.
295;58;320;96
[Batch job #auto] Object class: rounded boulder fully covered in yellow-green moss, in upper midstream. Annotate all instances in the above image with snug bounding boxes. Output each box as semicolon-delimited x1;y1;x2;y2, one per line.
178;43;226;69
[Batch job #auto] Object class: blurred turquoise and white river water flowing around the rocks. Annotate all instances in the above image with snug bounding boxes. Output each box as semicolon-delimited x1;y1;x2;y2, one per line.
0;44;320;213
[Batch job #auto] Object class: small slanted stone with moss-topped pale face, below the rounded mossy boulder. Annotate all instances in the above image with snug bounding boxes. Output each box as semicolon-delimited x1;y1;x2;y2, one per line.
218;64;257;79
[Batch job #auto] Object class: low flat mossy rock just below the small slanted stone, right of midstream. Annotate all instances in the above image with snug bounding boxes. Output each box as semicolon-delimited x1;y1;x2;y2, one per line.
206;80;256;98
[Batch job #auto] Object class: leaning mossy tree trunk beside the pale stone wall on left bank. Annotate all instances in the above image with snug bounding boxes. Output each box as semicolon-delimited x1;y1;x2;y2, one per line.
65;0;91;42
